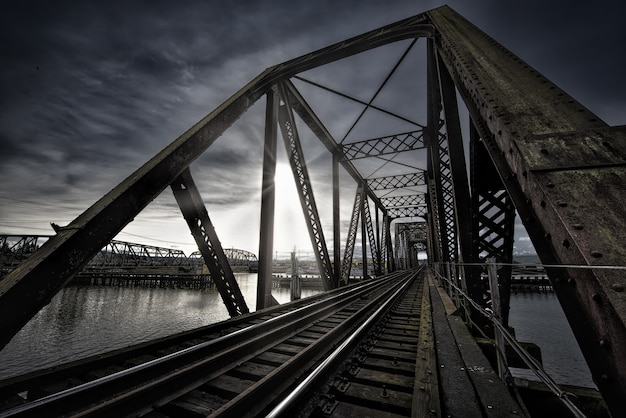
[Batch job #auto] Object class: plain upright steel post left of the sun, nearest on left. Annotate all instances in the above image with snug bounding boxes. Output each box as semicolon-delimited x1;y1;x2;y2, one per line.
256;90;278;310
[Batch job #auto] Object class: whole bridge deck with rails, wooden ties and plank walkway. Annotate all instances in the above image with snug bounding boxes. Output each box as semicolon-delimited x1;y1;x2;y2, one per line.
0;271;560;417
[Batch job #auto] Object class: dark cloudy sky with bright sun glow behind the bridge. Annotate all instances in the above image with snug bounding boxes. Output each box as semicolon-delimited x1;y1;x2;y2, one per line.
0;0;626;253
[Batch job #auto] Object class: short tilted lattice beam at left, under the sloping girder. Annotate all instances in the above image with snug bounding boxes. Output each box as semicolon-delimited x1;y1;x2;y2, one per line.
170;168;249;316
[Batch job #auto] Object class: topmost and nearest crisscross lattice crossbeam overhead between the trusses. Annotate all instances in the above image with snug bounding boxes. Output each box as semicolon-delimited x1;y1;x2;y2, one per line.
340;130;424;160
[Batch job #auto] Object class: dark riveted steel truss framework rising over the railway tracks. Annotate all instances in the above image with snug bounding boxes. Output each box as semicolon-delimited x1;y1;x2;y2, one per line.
0;7;626;416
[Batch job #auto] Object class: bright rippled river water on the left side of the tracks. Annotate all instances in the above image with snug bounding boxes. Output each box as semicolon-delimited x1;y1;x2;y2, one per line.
0;274;317;379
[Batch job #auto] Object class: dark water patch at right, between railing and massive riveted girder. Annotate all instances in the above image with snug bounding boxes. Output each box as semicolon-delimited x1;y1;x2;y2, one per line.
509;293;595;387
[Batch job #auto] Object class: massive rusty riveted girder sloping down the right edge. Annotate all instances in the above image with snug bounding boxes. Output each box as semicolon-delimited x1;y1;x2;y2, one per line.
429;8;626;415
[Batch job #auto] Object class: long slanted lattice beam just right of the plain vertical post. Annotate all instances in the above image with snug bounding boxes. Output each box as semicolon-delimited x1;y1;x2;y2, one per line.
278;86;337;290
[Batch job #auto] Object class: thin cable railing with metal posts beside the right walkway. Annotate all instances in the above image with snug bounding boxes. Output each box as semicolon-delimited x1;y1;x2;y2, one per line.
434;259;588;418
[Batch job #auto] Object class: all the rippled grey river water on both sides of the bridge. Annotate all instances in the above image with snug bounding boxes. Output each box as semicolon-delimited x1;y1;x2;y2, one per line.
0;273;593;387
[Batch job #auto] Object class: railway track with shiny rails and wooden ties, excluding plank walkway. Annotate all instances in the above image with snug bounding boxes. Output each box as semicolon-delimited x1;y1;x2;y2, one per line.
0;271;423;417
